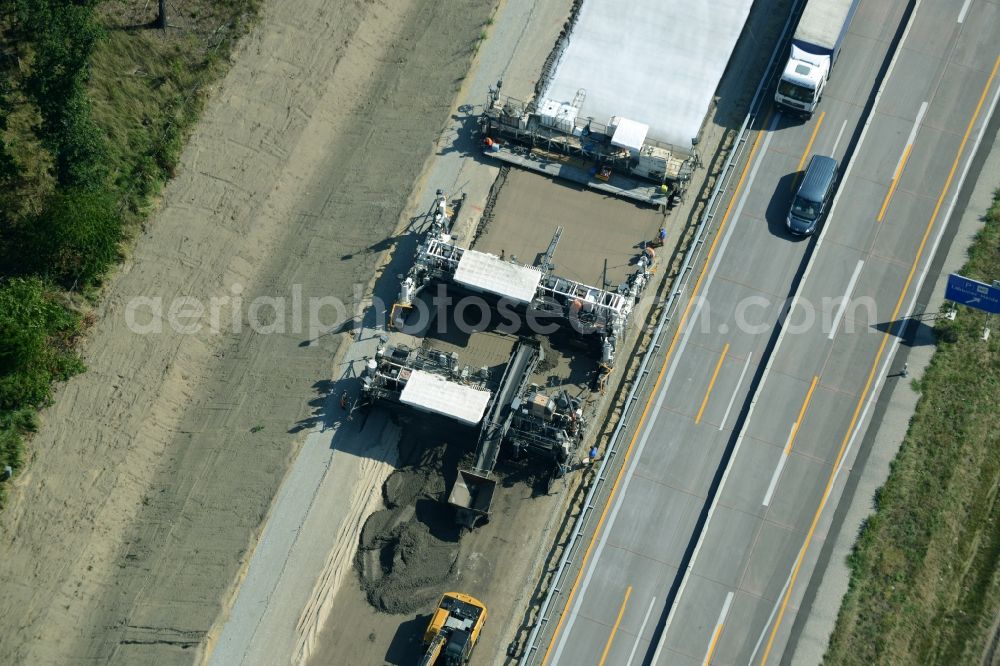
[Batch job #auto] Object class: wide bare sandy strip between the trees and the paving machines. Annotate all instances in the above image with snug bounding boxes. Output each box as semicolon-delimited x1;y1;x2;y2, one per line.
0;0;494;664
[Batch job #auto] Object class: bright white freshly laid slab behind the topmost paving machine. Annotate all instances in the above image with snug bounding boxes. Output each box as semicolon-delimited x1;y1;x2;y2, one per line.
542;0;753;149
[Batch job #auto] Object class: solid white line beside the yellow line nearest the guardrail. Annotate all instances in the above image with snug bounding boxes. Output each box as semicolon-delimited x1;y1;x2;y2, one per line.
551;114;781;666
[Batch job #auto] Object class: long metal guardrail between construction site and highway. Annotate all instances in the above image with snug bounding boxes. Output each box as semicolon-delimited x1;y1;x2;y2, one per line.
519;0;804;666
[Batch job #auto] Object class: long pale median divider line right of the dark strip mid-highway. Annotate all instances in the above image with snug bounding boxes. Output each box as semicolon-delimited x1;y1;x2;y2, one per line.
652;0;923;652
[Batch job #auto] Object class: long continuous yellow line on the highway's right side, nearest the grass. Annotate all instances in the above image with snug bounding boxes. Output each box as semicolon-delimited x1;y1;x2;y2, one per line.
760;56;1000;666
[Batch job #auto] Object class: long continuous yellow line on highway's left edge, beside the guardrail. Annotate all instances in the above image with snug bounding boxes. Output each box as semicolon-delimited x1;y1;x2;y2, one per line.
542;113;771;666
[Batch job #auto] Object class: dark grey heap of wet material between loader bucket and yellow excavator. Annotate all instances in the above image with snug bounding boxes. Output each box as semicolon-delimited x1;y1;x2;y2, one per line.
354;468;459;613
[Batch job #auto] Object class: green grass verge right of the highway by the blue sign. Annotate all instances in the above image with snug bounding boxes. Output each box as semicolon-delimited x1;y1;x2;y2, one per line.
824;190;1000;666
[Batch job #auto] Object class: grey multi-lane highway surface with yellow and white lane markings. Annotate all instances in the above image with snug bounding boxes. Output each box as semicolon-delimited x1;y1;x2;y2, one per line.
544;0;1000;665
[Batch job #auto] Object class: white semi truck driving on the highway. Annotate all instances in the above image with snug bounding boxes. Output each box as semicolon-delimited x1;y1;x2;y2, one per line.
774;0;860;116
